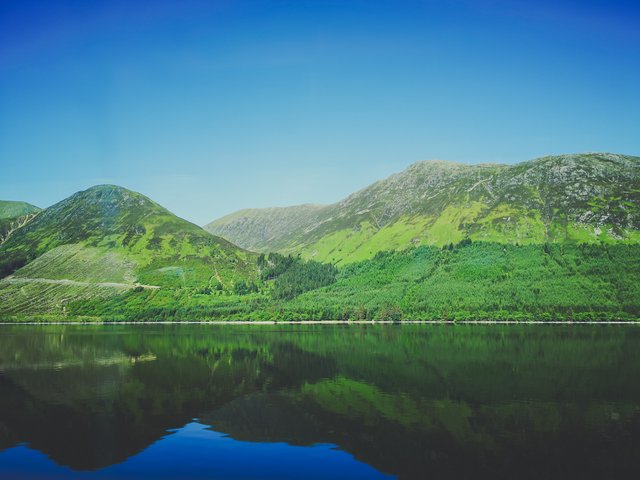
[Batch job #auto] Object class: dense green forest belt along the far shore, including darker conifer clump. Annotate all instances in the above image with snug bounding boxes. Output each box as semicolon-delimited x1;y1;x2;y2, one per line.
6;241;640;321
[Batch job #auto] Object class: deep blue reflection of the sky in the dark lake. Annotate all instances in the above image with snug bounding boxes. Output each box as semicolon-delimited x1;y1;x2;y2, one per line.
0;421;390;480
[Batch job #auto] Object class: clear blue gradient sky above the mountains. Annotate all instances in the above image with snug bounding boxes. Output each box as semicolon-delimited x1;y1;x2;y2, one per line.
0;0;640;224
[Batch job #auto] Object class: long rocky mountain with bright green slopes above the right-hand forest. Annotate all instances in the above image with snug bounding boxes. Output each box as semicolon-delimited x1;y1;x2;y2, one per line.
207;153;640;263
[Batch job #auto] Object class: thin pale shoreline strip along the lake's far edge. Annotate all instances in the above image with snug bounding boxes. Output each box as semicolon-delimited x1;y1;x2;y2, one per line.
0;320;640;326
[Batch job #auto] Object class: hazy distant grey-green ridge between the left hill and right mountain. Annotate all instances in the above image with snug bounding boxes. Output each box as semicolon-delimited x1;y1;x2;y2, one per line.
204;204;325;252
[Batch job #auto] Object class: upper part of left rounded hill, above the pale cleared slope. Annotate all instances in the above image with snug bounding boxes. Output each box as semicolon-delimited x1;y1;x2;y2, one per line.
0;185;252;282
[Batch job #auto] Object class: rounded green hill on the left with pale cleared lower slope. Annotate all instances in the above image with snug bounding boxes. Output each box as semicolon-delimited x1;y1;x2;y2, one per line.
0;185;255;313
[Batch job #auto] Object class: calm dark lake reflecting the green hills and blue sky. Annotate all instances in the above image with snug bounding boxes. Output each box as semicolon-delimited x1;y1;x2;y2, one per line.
0;325;640;479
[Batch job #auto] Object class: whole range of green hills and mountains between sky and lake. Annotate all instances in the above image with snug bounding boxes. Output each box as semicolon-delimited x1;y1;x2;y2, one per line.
0;153;640;322
